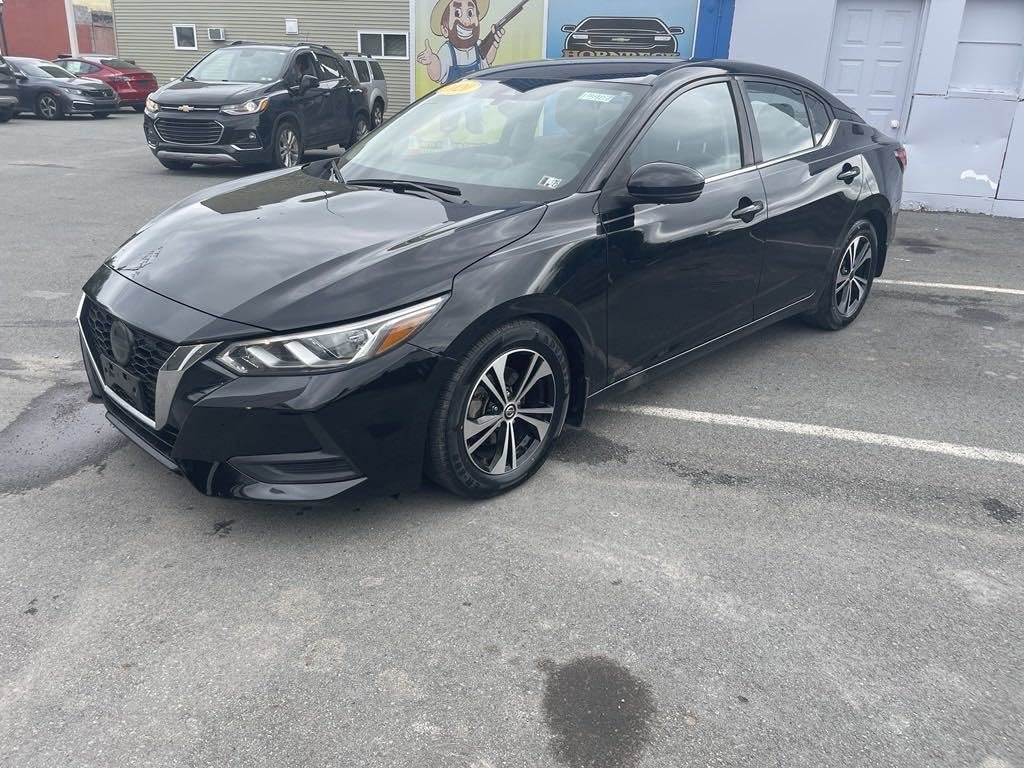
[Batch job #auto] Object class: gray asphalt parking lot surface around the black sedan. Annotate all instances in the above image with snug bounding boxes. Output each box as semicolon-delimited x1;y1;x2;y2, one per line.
0;113;1024;768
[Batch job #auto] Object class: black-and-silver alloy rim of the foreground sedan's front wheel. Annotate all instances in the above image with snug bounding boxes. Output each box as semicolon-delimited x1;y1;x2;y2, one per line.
462;349;557;475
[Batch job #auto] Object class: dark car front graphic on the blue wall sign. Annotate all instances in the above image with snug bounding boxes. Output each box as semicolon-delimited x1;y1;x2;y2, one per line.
562;16;685;57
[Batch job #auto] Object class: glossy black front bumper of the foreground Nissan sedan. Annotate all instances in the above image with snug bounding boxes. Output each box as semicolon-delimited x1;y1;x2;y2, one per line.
79;267;450;502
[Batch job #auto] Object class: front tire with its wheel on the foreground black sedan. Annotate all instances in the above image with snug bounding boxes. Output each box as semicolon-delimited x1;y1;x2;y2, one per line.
427;319;569;499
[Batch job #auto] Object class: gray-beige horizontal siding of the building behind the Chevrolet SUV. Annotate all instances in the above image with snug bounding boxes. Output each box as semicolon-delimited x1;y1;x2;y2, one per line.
114;0;415;114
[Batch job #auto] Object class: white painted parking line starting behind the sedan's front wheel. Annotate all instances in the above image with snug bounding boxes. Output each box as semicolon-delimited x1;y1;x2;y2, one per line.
600;406;1024;467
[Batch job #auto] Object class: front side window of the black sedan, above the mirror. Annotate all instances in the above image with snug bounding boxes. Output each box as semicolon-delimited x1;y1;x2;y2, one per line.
630;83;743;176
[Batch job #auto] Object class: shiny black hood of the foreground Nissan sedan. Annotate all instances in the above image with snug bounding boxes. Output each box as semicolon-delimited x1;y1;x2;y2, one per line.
108;161;545;331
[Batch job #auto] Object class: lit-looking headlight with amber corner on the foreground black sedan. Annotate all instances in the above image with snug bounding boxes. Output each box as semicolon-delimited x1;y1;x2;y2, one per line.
217;296;447;375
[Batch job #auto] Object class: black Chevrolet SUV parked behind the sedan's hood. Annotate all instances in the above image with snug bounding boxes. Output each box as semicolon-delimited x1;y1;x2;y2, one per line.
145;41;370;171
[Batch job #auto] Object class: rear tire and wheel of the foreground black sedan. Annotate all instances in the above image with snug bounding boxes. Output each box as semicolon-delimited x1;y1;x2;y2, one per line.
803;219;879;331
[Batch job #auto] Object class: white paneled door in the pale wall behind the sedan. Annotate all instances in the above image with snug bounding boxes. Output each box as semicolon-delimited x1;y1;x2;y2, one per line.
825;0;922;136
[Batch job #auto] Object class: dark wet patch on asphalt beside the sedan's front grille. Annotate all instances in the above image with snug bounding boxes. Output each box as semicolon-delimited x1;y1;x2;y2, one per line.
0;384;126;494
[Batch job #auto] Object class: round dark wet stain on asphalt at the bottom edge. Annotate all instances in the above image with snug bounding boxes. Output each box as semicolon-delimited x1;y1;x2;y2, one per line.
540;656;656;768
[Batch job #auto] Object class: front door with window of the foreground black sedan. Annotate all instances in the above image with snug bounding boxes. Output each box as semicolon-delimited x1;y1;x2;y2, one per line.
600;80;766;381
